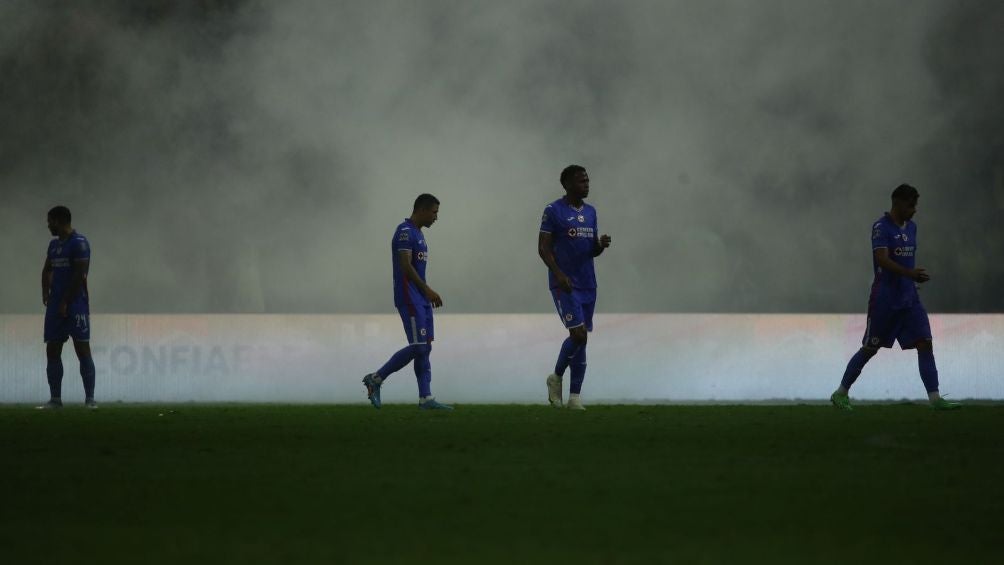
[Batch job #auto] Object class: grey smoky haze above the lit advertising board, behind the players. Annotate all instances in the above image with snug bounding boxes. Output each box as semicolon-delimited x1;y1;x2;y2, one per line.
0;0;1004;312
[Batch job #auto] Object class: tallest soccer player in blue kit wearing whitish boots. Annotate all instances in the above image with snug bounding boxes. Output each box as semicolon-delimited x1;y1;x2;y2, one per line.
537;165;610;410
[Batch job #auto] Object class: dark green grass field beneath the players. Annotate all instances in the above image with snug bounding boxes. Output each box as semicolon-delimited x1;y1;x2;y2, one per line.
0;404;1004;565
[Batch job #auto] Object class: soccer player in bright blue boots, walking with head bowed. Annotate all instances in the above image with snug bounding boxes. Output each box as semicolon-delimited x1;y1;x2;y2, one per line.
362;194;453;410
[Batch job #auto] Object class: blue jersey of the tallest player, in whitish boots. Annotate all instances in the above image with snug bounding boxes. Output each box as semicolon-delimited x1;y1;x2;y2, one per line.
540;198;599;289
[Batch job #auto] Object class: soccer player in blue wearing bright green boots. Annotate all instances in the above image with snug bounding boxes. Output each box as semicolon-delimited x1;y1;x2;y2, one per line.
829;185;960;410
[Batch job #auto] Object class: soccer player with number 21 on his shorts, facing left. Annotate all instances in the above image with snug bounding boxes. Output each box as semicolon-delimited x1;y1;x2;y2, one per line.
38;206;97;409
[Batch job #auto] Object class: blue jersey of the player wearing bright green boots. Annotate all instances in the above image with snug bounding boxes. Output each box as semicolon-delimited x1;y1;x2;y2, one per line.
868;213;920;309
